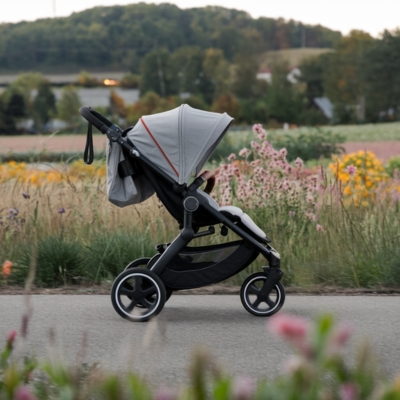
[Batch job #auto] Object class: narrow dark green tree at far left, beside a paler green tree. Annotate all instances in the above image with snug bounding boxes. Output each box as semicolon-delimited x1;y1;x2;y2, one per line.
33;80;56;130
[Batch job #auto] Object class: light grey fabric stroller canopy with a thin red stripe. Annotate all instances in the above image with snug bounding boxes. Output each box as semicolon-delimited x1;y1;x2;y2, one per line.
127;104;233;184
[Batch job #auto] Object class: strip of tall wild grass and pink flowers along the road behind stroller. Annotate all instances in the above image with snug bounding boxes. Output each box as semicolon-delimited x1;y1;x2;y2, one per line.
0;130;400;287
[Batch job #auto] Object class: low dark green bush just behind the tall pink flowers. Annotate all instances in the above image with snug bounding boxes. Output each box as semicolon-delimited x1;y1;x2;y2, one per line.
270;128;345;161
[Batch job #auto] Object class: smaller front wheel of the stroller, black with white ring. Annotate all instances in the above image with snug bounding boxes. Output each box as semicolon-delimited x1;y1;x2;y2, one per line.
240;272;285;317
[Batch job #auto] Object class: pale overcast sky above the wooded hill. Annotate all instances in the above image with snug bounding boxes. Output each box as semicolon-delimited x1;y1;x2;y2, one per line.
0;0;400;37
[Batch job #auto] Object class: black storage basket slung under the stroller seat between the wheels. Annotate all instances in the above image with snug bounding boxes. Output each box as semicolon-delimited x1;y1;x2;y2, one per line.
160;240;259;290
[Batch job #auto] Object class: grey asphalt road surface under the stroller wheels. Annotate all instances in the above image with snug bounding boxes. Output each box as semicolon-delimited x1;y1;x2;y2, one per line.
0;295;400;384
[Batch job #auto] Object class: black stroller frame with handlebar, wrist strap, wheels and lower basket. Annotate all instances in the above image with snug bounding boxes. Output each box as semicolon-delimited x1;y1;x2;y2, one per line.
79;107;285;321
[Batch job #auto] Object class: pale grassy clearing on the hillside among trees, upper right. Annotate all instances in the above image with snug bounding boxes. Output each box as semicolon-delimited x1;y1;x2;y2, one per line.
261;47;333;68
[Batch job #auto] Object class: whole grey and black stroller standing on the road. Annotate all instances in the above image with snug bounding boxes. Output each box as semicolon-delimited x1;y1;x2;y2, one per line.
79;105;285;321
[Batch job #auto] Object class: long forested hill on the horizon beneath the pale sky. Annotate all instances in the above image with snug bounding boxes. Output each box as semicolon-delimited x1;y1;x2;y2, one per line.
0;3;341;73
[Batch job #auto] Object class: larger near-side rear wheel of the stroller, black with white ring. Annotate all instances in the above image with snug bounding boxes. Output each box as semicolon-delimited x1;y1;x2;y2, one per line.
111;268;167;322
